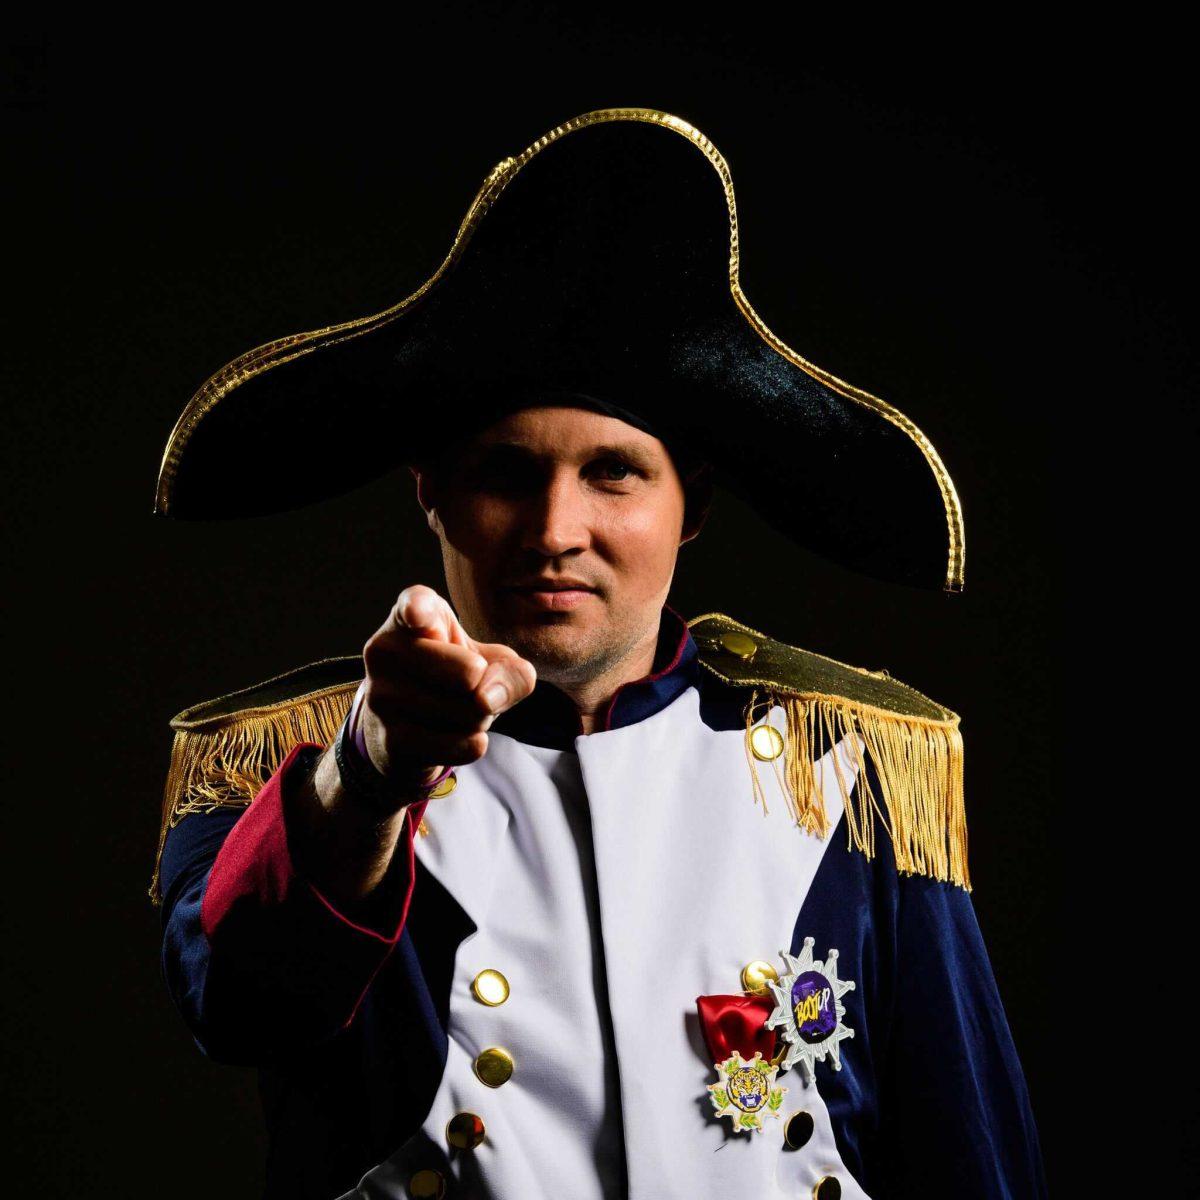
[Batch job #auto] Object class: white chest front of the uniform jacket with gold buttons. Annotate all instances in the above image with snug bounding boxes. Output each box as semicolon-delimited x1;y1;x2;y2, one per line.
347;690;864;1198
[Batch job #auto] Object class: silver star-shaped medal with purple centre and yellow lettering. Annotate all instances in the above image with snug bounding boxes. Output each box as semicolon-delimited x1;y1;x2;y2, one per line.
766;937;854;1084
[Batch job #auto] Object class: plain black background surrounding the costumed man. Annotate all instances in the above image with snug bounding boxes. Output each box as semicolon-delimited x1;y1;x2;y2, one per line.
4;6;1190;1198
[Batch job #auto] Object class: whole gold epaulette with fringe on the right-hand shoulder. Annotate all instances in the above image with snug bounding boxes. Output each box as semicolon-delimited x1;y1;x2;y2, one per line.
688;612;971;892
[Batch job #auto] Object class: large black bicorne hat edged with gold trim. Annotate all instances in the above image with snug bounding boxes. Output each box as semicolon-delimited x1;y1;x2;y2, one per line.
155;108;964;592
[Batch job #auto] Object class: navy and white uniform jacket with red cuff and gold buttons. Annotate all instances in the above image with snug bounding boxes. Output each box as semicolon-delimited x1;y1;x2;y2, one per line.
154;607;1045;1200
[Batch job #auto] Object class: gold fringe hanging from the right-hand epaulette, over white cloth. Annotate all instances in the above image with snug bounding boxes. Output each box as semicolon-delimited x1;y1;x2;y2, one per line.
744;688;971;892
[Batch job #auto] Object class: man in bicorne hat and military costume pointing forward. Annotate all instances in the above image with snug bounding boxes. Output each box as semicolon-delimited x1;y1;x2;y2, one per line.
155;110;1044;1200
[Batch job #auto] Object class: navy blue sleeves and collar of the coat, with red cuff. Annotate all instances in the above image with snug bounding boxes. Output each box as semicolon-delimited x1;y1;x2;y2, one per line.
161;607;1045;1200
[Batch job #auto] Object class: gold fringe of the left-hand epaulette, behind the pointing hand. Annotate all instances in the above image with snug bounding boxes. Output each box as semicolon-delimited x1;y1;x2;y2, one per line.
150;680;359;905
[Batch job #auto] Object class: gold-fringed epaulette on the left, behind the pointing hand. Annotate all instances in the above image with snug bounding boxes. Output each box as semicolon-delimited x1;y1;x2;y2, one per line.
150;654;362;904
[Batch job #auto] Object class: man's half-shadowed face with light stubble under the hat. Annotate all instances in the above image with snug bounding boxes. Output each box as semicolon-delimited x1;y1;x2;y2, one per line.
412;407;707;683
